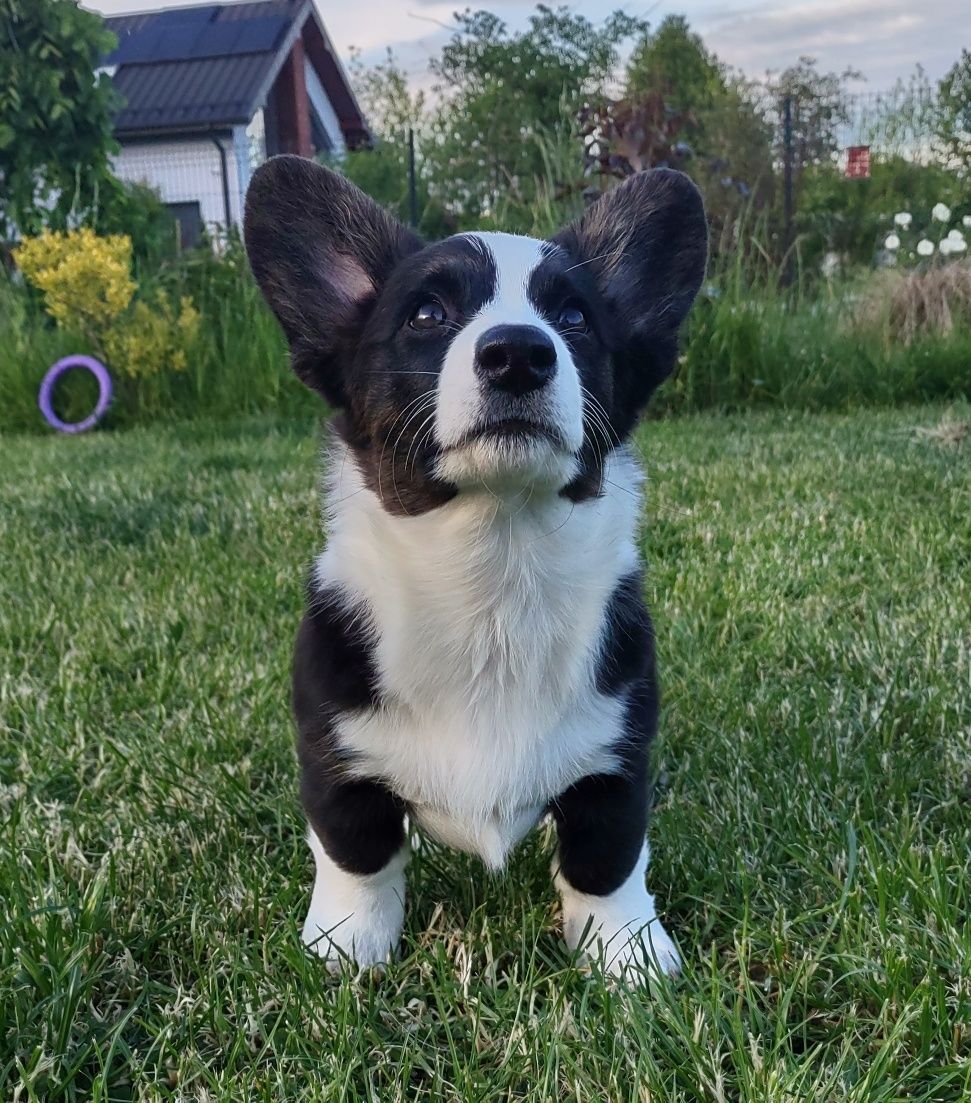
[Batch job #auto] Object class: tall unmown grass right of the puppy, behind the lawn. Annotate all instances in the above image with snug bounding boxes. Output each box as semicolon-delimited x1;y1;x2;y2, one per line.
655;207;971;413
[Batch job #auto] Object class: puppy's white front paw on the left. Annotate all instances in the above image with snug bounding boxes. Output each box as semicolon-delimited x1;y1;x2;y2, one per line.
302;831;407;972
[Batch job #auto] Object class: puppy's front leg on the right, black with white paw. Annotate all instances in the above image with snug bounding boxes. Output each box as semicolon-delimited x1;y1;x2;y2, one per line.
551;684;680;973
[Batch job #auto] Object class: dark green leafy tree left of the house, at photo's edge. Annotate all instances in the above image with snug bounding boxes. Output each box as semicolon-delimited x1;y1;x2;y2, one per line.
0;0;116;235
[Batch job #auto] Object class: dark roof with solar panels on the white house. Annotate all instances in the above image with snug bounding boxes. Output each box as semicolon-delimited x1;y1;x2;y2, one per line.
102;0;366;137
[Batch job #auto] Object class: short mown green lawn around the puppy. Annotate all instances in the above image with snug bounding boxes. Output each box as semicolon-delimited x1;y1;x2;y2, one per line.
0;408;971;1103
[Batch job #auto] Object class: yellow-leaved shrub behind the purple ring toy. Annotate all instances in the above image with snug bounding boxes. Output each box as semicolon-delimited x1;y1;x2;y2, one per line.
13;227;200;378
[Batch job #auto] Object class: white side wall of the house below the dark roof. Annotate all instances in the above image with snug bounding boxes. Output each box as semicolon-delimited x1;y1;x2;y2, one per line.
113;137;242;227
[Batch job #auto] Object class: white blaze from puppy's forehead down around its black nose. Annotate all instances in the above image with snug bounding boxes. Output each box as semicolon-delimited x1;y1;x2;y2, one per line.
435;233;583;480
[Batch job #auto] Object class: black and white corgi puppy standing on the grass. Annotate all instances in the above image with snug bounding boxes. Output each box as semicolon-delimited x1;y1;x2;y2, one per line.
245;157;707;973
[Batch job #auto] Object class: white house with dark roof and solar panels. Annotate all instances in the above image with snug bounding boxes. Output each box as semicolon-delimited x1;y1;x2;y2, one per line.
103;0;370;245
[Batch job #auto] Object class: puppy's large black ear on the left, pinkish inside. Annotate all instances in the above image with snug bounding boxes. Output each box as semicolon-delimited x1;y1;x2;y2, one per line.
244;157;422;407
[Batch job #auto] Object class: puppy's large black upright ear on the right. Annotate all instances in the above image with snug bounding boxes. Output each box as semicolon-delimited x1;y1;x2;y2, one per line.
553;169;708;409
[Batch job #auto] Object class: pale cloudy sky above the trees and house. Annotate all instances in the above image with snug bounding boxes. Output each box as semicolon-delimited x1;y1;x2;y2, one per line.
84;0;971;92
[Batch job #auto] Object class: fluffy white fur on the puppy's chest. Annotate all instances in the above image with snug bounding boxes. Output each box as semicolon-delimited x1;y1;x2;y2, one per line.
317;443;637;866
